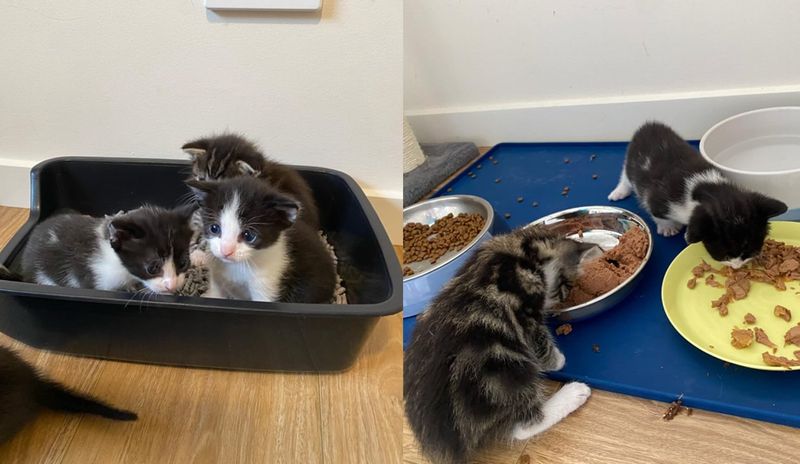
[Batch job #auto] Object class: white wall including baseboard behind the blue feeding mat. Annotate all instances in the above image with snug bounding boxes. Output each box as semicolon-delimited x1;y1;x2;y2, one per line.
404;0;800;144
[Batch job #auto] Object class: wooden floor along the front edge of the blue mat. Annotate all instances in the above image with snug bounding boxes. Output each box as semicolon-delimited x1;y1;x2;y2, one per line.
403;147;800;464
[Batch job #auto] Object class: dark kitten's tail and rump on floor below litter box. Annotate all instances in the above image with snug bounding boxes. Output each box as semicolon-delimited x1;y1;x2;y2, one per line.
0;347;136;443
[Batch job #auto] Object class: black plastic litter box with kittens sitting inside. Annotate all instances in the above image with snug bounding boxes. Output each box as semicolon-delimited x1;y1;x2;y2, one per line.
0;157;402;372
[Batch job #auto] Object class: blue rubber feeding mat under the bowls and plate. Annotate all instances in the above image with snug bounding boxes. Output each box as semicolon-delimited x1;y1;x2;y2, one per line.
404;143;800;427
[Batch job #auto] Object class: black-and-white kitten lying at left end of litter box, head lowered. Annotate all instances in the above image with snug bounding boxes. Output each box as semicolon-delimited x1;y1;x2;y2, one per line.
22;206;196;293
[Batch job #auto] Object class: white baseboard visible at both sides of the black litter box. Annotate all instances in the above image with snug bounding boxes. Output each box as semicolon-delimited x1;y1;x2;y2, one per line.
0;158;403;245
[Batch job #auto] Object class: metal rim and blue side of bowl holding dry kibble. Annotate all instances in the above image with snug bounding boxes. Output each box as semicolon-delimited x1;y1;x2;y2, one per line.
403;195;508;317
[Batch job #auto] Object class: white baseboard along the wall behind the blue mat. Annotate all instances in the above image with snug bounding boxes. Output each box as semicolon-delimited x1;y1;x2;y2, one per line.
406;86;800;146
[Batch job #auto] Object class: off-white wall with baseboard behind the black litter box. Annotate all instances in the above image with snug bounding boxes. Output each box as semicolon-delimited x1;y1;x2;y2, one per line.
0;0;402;241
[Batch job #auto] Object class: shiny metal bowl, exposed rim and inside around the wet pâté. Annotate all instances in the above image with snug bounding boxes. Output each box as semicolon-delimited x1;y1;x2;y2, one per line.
526;206;653;321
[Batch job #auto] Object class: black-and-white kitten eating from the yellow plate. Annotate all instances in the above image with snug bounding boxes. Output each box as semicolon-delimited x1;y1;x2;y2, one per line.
608;122;787;268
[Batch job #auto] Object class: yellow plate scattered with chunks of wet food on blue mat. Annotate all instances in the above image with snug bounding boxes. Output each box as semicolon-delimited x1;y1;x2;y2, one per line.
661;222;800;371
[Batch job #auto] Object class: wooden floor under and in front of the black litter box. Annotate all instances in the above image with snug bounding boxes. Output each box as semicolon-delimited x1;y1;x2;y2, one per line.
0;207;402;464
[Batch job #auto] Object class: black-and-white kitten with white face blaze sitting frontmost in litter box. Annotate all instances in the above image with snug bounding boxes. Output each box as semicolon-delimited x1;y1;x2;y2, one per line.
187;176;336;303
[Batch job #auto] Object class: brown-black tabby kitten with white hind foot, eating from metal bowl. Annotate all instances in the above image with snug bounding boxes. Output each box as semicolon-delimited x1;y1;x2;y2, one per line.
403;227;595;463
